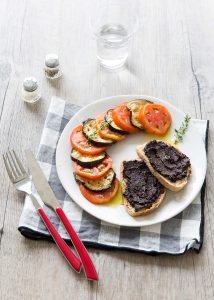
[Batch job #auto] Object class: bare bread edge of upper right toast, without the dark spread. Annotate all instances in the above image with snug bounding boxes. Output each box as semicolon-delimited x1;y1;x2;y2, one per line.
136;142;192;192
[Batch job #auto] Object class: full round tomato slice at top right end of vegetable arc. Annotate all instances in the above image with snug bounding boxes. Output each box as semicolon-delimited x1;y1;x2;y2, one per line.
139;103;172;135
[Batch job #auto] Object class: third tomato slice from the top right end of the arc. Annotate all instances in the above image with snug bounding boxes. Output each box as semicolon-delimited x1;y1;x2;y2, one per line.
96;113;126;141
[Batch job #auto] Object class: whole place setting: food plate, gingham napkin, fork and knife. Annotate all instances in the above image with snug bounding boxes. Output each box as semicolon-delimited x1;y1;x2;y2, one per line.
3;95;208;281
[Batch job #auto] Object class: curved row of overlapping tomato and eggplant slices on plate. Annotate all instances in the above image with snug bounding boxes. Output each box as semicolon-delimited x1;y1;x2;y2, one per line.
70;100;171;204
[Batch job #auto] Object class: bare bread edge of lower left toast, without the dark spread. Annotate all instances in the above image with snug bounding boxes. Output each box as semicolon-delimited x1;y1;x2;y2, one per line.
121;161;166;217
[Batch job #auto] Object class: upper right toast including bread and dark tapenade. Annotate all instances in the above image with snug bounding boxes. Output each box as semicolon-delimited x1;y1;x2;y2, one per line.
136;140;192;192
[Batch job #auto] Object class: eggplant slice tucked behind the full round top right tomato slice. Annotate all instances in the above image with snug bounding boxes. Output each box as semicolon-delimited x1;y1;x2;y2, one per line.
126;100;152;130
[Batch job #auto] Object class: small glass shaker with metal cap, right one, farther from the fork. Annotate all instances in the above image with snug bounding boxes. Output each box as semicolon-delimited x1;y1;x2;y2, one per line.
45;53;62;79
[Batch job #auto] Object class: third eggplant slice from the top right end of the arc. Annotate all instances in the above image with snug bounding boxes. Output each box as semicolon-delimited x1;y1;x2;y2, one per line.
82;119;114;147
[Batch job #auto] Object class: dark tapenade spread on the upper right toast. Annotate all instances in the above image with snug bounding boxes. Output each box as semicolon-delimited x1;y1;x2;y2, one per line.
144;140;190;182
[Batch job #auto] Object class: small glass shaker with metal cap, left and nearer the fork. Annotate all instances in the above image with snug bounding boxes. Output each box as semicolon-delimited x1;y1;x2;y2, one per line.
22;77;41;103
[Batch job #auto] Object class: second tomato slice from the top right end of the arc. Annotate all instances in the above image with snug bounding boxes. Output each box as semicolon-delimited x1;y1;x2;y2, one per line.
112;104;139;133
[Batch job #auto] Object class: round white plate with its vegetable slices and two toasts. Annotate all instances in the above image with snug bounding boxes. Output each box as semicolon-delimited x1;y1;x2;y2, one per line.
56;95;206;227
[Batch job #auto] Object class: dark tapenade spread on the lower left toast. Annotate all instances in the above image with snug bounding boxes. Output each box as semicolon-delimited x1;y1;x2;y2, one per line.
123;160;164;211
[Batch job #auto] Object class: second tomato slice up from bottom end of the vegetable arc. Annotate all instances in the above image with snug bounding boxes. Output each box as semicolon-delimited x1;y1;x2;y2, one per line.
73;156;112;179
